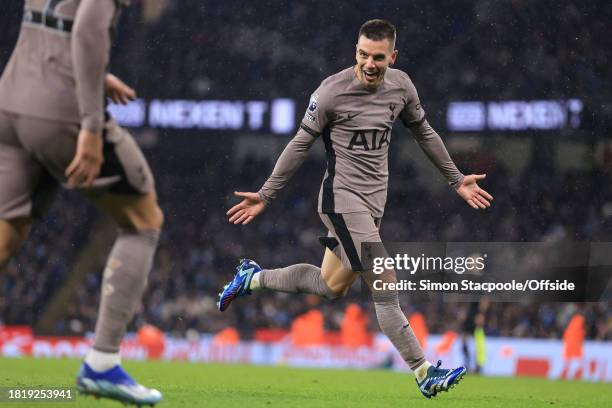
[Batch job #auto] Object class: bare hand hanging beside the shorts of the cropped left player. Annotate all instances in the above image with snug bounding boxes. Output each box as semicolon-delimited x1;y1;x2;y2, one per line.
64;129;104;187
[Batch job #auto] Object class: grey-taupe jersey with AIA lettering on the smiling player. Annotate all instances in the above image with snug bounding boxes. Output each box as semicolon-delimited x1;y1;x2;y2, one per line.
301;67;425;217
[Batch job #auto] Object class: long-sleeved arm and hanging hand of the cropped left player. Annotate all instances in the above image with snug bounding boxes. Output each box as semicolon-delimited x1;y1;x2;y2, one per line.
65;0;116;187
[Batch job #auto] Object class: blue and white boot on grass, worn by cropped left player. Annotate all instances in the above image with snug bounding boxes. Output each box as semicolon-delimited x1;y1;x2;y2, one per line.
77;363;162;407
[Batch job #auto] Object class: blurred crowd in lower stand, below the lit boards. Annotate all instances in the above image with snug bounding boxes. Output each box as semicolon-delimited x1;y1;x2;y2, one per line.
0;151;612;339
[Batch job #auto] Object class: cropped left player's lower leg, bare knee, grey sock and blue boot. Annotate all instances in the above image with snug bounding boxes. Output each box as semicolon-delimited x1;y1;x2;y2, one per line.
77;192;163;404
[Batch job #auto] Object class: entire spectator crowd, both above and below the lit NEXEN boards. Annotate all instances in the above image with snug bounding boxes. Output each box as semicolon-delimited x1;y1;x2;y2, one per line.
0;0;612;340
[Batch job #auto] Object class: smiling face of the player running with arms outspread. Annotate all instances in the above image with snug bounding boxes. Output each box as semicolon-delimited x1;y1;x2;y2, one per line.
355;35;397;88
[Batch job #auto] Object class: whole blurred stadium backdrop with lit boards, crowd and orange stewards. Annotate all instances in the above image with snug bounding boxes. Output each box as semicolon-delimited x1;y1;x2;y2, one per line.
0;0;612;381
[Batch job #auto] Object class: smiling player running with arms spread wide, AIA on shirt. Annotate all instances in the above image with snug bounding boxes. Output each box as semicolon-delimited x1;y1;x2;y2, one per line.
219;20;493;398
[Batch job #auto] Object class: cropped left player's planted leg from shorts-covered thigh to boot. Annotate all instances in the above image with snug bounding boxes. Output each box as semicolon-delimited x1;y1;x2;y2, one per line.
77;123;163;404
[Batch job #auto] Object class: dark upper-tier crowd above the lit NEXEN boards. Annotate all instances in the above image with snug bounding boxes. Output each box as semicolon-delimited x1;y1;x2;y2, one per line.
107;0;612;105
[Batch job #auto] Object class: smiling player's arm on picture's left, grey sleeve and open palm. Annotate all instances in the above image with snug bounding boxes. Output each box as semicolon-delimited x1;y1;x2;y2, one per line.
227;126;317;224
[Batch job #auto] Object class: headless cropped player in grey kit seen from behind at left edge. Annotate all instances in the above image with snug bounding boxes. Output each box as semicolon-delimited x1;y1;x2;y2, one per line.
0;0;163;405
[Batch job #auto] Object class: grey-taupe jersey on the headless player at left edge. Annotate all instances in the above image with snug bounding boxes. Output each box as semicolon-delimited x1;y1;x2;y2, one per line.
0;0;124;132
